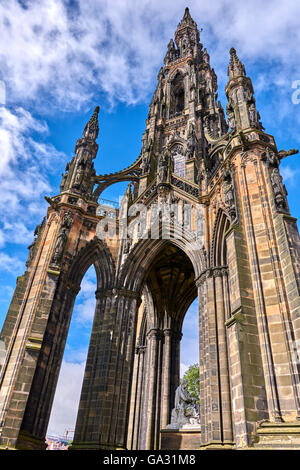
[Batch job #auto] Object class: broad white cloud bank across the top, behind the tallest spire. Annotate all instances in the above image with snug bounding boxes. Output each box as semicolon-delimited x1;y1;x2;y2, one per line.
0;0;300;109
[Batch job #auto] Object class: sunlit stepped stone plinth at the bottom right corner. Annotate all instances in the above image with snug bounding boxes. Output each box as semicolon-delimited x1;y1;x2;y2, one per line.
254;421;300;450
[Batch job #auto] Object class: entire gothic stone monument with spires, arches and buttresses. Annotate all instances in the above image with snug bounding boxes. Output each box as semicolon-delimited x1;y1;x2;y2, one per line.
0;9;300;449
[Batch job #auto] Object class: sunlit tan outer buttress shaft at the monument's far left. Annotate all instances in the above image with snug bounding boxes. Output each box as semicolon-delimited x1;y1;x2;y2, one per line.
0;214;59;448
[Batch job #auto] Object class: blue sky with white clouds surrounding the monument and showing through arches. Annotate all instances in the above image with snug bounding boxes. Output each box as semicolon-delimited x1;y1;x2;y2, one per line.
0;0;300;436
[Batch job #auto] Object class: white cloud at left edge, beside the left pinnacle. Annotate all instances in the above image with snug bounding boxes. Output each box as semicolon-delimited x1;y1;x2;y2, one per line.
0;107;66;246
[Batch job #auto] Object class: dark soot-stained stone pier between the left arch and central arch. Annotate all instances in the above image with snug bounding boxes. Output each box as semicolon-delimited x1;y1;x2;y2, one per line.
72;289;140;449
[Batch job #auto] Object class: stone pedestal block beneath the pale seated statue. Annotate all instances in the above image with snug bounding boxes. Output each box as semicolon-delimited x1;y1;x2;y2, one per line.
160;427;201;450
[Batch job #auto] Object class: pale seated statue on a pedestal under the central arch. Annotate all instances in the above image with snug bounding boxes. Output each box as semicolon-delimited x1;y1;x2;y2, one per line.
167;380;200;429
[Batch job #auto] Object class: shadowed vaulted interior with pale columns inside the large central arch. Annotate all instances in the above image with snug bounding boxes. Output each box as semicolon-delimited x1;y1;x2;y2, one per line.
128;242;197;449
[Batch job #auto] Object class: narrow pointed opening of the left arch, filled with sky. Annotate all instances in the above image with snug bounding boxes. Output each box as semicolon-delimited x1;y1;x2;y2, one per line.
46;266;97;449
